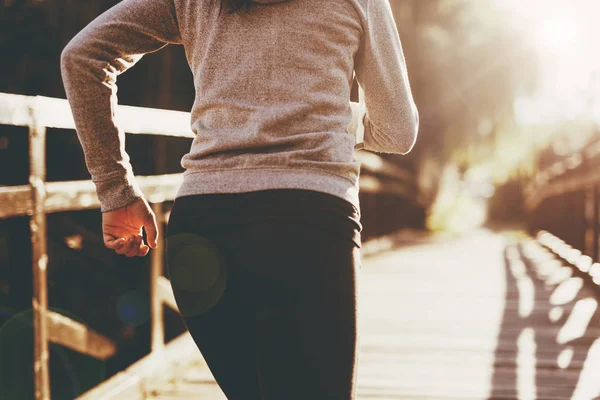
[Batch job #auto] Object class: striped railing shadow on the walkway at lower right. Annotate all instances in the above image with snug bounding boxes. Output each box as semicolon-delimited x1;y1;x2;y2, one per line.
488;240;600;400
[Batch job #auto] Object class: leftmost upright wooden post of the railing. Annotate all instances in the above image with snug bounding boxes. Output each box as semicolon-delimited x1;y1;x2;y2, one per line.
29;108;50;400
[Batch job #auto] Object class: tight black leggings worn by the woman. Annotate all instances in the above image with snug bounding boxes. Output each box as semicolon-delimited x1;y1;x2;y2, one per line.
167;189;362;400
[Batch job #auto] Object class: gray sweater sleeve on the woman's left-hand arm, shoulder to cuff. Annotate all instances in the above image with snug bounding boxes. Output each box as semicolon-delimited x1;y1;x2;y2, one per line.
60;0;181;212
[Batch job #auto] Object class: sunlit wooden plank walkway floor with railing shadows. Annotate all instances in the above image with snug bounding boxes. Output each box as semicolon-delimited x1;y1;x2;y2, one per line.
83;230;600;400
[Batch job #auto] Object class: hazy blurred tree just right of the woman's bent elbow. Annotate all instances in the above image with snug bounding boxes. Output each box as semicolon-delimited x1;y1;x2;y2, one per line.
390;0;536;205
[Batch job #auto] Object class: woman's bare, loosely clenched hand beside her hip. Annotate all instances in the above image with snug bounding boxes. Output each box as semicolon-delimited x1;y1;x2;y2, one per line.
102;198;158;257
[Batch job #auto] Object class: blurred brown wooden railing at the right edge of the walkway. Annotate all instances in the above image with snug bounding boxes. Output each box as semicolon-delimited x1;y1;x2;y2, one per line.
524;134;600;286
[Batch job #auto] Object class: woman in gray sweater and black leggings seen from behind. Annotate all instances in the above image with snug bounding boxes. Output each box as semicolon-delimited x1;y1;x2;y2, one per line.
61;0;418;400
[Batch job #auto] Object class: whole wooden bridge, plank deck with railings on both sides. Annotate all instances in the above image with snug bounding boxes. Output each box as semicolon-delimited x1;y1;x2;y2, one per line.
0;94;600;400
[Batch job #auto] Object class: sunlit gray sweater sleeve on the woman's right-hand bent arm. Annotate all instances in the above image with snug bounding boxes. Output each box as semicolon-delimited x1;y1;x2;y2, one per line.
353;0;419;154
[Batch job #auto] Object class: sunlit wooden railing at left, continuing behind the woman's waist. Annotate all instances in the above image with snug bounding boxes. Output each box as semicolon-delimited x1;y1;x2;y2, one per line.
0;93;419;400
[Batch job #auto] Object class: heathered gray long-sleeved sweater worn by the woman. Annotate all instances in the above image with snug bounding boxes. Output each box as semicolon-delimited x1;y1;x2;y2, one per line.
61;0;418;212
